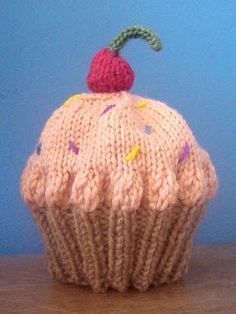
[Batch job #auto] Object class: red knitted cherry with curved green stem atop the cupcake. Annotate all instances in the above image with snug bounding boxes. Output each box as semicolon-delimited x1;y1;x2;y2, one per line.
87;26;161;93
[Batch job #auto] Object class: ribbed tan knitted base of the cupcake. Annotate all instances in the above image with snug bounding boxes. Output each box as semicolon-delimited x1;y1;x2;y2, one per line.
32;207;203;292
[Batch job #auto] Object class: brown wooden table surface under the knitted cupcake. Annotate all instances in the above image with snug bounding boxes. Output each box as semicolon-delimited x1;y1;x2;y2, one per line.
0;244;236;314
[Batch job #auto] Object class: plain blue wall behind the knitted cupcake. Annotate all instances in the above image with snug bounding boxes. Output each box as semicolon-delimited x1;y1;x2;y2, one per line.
0;0;236;254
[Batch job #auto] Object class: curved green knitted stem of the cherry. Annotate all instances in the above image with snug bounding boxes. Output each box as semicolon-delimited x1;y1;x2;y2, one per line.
108;26;162;51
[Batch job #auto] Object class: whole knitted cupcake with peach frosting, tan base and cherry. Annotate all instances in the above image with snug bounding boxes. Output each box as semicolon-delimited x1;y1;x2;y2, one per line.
21;26;217;292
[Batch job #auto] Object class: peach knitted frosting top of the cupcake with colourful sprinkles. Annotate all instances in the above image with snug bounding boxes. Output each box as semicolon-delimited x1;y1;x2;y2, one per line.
21;91;217;211
